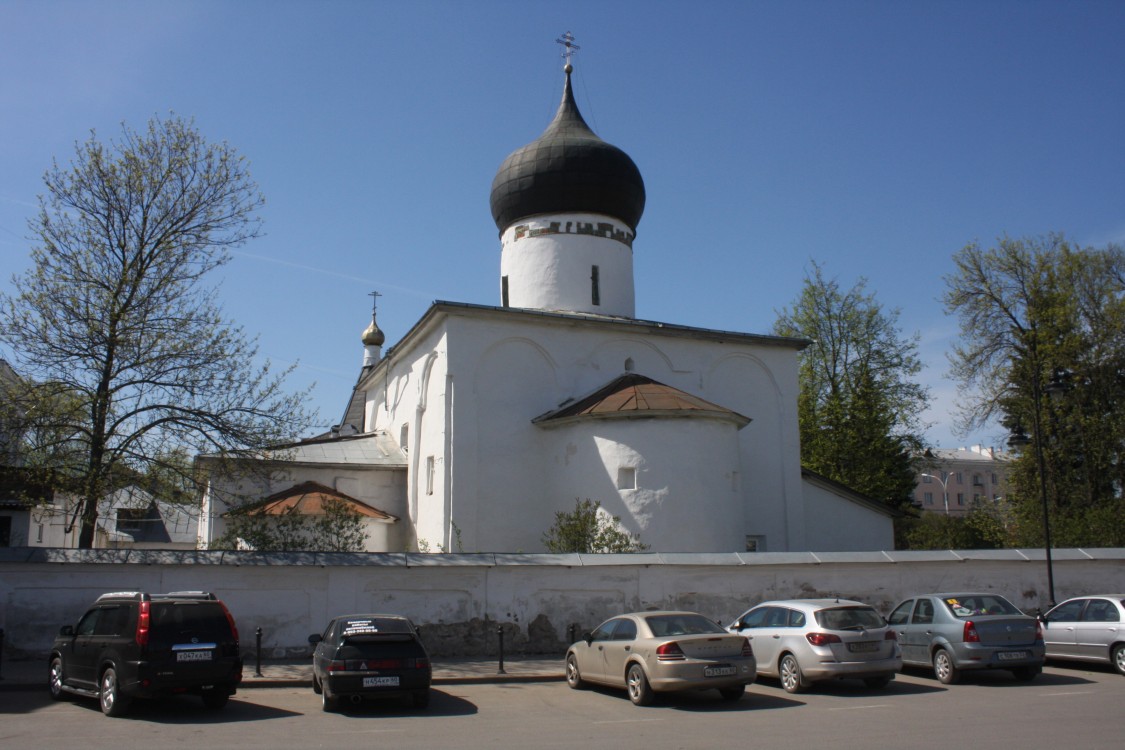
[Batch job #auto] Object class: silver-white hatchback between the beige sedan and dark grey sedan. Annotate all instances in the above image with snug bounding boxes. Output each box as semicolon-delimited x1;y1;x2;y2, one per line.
727;599;902;693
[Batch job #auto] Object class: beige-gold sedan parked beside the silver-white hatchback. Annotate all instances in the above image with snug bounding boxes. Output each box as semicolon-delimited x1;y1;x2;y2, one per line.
566;611;757;706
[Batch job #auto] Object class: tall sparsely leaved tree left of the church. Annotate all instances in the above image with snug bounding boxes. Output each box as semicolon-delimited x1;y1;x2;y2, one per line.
0;116;309;548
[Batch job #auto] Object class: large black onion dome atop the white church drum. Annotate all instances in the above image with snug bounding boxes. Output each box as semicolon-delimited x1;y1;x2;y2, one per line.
489;70;645;232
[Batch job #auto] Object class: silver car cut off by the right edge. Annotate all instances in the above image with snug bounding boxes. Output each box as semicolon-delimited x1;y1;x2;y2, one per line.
1042;594;1125;675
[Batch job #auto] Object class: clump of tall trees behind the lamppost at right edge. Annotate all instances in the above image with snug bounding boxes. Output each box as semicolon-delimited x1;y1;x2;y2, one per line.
944;234;1125;546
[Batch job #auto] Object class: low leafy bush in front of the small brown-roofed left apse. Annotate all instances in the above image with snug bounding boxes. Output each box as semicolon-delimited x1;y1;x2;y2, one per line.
210;499;368;552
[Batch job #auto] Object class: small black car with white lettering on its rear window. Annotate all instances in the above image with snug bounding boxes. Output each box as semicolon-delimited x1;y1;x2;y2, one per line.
308;615;433;711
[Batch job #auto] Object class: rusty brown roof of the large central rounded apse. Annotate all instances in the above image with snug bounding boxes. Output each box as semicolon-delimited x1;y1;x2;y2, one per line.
532;372;750;428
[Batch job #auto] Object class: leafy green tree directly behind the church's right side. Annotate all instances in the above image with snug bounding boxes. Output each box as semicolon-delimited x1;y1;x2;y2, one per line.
774;263;929;508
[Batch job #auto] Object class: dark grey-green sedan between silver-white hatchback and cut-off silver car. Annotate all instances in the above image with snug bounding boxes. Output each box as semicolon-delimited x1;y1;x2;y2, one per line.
888;593;1044;685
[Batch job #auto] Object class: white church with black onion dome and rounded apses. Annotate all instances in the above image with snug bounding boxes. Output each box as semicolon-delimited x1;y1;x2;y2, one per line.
198;51;894;552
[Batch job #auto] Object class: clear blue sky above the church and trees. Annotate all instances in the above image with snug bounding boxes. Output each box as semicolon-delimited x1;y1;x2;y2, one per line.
0;0;1125;448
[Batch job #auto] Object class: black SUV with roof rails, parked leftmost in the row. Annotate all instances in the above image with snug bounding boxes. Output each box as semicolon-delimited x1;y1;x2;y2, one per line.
51;591;242;716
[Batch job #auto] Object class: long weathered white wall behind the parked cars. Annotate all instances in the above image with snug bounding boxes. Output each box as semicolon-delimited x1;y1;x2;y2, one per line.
0;548;1125;660
